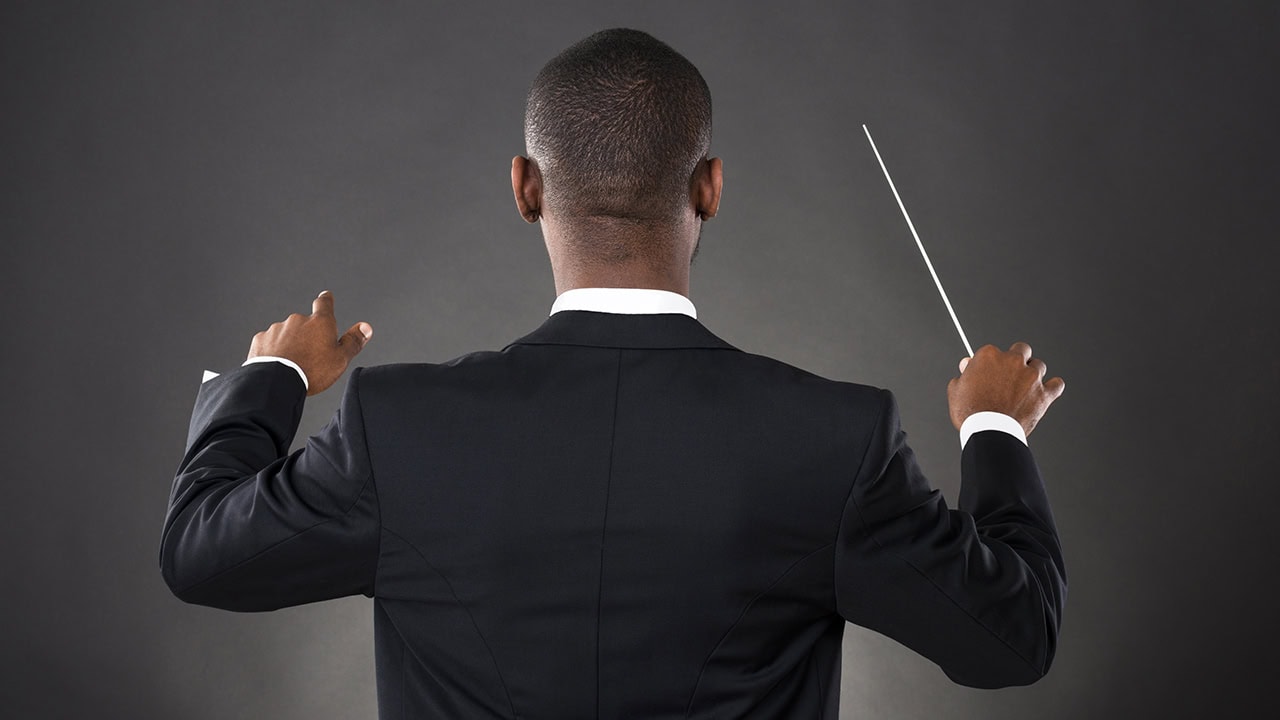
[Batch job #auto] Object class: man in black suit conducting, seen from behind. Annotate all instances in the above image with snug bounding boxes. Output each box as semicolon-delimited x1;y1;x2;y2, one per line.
160;29;1066;719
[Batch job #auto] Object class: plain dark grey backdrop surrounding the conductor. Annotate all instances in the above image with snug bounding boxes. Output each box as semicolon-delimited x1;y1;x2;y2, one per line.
0;1;1280;719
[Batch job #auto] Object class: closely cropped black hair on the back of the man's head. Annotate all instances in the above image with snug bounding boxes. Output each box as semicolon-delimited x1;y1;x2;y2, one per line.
525;28;712;224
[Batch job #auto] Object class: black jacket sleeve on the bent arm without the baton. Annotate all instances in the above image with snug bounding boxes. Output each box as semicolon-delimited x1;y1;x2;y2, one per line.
160;363;380;611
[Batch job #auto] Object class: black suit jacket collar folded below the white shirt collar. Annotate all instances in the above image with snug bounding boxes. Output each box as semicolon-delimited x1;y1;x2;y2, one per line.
507;310;737;350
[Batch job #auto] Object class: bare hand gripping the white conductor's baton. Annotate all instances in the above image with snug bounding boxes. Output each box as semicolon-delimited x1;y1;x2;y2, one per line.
947;342;1066;436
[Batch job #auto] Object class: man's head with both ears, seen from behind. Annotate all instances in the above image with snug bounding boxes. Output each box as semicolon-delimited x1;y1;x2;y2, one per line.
512;29;719;288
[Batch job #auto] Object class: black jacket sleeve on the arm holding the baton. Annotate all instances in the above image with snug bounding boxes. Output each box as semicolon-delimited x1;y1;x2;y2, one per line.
835;391;1066;688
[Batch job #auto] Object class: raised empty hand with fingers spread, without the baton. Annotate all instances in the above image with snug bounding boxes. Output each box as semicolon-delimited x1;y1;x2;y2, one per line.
248;290;374;396
